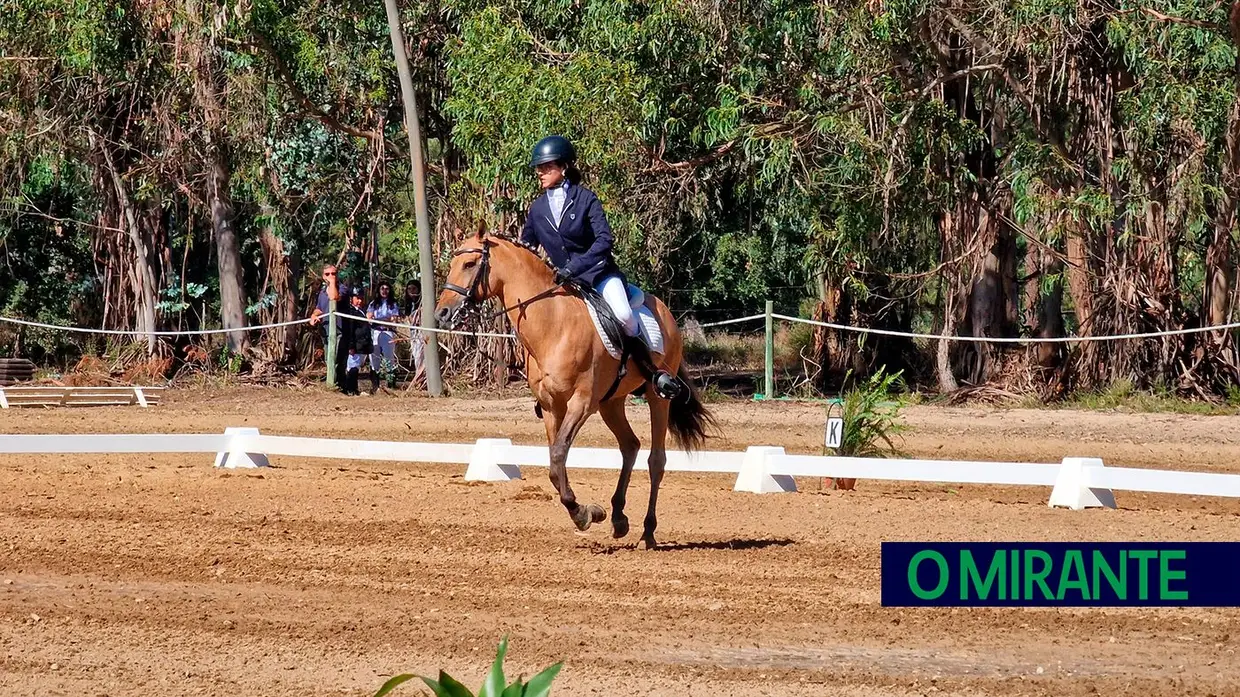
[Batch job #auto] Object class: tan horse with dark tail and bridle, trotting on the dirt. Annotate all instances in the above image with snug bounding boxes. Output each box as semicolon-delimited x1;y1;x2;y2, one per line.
435;229;714;549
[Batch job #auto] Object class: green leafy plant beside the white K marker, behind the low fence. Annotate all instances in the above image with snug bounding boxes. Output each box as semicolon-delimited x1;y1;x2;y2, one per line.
827;368;905;458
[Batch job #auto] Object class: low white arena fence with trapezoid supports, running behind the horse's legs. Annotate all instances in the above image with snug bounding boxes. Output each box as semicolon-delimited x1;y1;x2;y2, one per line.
0;428;1240;510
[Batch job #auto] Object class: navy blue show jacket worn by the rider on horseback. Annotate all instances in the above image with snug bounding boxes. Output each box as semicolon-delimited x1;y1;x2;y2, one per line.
521;184;625;288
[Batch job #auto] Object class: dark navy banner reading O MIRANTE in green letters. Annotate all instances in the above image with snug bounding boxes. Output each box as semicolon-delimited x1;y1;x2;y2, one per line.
882;542;1240;608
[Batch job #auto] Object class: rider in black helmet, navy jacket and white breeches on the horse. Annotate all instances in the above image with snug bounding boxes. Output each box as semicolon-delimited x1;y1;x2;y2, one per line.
521;135;682;399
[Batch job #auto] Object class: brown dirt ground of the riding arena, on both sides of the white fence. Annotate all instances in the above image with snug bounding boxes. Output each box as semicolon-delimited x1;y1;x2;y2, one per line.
0;388;1240;697
